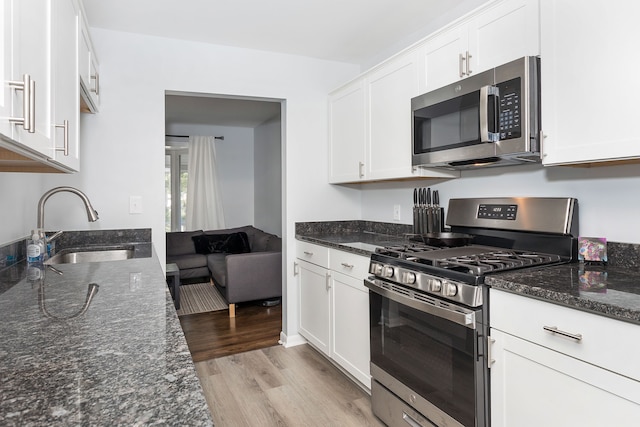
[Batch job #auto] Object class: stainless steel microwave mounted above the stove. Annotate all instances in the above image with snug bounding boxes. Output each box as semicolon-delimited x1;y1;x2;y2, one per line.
411;57;540;169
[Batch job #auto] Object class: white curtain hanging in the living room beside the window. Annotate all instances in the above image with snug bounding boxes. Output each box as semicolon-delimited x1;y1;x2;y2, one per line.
186;136;225;230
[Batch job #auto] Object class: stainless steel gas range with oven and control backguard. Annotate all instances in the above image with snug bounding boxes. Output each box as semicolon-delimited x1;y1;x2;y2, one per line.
365;198;578;427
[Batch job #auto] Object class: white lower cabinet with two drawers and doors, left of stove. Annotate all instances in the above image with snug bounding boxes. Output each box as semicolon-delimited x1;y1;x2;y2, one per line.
296;242;371;389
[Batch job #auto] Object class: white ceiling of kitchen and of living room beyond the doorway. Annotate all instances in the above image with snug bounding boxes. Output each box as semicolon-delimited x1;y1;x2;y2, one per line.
83;0;486;127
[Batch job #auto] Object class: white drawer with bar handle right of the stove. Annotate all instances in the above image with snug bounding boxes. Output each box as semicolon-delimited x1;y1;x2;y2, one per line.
489;289;640;381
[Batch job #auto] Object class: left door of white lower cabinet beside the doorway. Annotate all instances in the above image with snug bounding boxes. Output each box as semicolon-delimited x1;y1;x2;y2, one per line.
297;260;331;356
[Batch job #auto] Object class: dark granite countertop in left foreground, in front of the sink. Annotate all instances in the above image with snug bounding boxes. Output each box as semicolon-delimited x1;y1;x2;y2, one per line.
0;231;213;426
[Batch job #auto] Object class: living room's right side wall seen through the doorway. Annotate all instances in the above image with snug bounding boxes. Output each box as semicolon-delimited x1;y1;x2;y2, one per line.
253;119;282;236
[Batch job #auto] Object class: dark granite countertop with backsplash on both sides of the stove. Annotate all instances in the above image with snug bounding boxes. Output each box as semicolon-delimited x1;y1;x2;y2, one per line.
296;221;640;324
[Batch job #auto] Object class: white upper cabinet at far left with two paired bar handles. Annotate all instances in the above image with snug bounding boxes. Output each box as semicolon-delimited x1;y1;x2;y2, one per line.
0;0;53;157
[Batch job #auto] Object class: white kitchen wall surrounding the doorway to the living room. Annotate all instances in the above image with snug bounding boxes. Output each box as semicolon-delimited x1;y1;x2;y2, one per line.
18;29;360;344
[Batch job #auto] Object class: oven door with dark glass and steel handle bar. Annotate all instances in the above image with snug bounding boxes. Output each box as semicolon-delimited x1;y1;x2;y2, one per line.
365;278;488;426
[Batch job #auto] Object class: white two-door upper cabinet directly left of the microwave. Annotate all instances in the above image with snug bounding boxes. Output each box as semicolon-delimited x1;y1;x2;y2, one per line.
329;50;460;184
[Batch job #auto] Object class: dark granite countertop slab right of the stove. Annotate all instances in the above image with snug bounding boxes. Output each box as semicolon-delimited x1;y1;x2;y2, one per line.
485;263;640;324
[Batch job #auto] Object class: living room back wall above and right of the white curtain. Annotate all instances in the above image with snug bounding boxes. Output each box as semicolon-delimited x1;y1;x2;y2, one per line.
167;124;254;228
